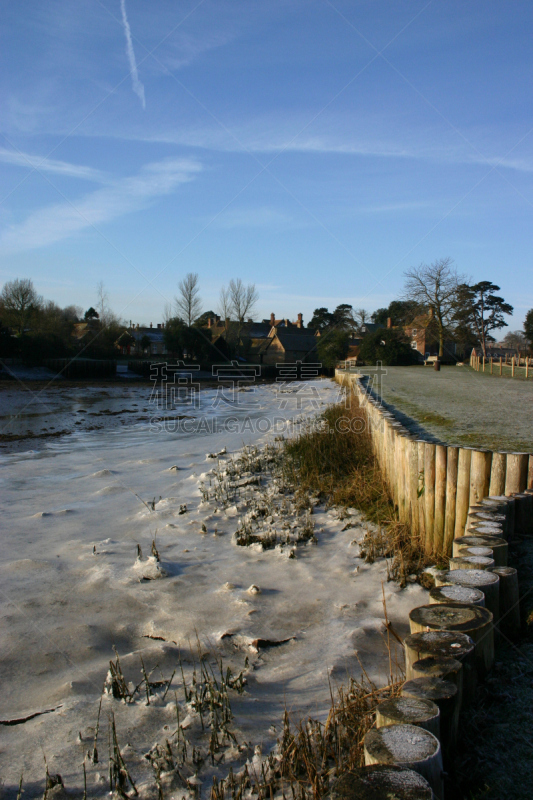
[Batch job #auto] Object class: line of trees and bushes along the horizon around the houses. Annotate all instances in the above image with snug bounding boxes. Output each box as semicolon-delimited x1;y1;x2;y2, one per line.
0;258;533;364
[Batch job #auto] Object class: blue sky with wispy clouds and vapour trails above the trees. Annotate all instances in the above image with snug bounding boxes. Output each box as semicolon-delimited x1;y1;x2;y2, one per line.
0;0;533;329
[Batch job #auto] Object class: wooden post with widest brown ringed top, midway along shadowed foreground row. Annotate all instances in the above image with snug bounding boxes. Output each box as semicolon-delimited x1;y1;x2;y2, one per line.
409;603;494;678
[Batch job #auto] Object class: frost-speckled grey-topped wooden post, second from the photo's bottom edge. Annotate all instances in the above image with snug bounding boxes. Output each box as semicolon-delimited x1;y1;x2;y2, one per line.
363;725;444;800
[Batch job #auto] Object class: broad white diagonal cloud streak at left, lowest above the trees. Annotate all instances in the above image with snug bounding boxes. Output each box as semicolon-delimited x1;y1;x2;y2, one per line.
0;159;202;254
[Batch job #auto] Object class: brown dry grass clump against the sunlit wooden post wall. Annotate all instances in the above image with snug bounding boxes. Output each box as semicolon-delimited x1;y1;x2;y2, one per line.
285;394;430;586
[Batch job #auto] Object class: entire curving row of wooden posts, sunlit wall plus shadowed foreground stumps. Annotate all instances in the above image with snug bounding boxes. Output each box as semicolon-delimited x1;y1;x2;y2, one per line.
331;374;533;800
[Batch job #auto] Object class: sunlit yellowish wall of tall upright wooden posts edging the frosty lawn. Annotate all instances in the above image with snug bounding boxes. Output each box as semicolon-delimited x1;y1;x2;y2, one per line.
336;370;533;556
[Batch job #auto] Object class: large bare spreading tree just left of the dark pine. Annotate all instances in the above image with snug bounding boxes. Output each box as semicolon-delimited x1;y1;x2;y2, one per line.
404;258;465;357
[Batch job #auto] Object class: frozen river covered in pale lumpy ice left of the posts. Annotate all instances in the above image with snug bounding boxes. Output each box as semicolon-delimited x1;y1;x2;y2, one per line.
0;380;427;798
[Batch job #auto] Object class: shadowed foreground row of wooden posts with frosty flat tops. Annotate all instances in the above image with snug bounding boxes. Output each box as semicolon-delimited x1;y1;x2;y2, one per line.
350;492;533;800
